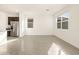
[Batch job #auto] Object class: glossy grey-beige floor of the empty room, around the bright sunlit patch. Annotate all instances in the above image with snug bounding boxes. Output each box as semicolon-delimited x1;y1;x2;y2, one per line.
0;35;79;55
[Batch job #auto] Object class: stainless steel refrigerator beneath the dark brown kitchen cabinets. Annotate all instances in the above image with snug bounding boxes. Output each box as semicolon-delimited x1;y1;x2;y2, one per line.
10;21;19;36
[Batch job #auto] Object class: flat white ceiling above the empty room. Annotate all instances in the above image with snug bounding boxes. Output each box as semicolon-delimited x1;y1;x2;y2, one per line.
0;4;66;14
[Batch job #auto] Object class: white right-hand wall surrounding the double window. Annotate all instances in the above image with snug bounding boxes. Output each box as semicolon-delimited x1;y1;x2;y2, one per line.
53;5;79;48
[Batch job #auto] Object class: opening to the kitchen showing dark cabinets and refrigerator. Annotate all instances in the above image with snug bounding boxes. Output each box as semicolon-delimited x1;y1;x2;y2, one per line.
7;17;19;40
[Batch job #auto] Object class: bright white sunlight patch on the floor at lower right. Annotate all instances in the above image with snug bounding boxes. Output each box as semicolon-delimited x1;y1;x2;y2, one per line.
48;43;66;55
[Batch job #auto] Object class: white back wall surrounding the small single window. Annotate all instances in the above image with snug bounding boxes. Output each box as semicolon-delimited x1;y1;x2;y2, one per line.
20;12;53;35
